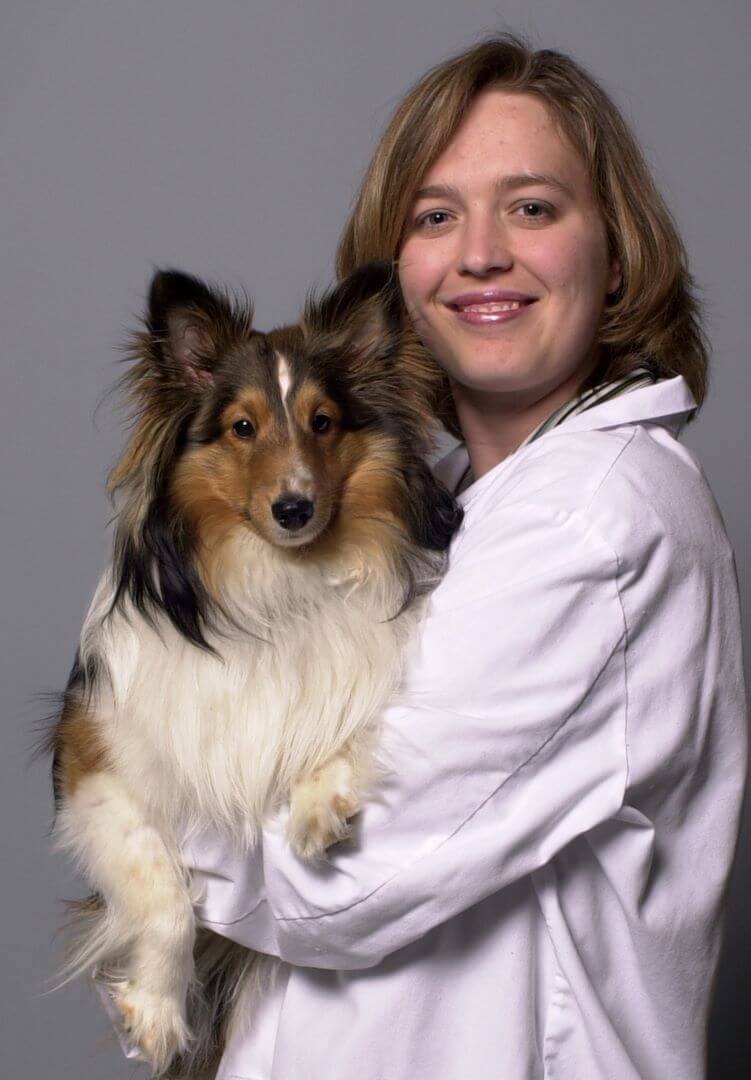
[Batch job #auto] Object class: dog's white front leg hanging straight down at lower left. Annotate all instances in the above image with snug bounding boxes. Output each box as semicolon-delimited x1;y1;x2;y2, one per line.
57;772;195;1072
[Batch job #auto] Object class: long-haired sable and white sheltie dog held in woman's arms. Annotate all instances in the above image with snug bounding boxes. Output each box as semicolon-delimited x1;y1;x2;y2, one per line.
50;264;461;1077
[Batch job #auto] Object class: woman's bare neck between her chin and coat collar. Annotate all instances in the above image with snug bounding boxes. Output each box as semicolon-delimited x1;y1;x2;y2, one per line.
450;364;594;480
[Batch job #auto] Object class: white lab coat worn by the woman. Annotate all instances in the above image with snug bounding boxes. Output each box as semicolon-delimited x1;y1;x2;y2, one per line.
186;378;747;1080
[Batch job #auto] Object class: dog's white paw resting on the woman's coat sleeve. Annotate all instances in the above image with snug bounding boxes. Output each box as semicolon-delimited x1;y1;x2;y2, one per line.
286;756;360;861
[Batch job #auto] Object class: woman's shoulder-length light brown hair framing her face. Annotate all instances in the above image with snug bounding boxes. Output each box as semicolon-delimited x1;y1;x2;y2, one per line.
337;33;708;406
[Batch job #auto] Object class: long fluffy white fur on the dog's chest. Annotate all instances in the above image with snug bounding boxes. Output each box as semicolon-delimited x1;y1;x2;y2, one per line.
81;531;418;842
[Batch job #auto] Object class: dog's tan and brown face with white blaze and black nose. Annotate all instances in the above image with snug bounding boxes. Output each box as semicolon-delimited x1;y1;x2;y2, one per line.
168;335;346;548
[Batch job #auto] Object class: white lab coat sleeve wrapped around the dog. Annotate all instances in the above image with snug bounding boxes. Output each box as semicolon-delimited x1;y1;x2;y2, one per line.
184;505;628;970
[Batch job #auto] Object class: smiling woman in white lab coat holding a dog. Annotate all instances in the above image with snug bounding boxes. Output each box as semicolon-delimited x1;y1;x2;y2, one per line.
182;37;746;1080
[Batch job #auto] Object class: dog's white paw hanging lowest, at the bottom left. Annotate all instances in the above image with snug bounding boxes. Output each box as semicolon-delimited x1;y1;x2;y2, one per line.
111;982;190;1076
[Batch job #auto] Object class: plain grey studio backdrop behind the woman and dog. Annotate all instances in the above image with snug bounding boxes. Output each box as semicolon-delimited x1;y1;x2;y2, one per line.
0;0;751;1080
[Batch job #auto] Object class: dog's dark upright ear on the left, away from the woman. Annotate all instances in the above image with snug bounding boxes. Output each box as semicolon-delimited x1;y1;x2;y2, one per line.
145;270;252;391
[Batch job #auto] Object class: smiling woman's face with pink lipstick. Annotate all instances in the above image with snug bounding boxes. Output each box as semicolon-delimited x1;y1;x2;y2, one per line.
399;90;620;402
